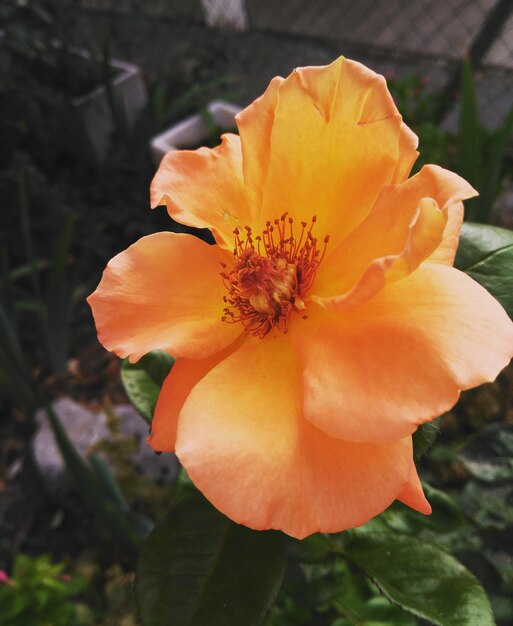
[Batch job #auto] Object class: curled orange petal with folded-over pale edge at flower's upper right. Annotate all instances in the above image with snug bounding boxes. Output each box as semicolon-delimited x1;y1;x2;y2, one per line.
313;165;476;299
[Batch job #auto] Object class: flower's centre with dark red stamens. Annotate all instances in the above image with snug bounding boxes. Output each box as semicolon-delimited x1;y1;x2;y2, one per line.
221;213;329;338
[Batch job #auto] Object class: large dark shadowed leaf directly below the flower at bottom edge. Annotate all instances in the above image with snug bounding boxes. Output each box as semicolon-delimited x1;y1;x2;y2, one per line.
135;495;285;626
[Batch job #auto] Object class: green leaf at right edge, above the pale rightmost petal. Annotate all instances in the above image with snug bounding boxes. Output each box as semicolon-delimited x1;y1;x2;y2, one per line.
455;224;513;317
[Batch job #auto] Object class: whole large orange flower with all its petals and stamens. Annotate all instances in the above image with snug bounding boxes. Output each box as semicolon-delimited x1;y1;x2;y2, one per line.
89;58;513;537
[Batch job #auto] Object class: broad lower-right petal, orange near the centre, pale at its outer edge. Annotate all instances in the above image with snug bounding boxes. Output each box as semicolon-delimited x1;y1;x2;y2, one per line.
289;263;513;442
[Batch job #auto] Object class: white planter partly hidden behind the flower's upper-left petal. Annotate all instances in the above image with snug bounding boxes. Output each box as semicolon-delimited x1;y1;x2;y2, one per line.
150;101;242;166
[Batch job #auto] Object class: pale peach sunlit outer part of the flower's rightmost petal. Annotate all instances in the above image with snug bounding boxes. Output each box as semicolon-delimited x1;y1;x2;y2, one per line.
369;263;513;390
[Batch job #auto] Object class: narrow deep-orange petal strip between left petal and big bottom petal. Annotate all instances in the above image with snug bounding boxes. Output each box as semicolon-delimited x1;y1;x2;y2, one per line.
148;337;244;452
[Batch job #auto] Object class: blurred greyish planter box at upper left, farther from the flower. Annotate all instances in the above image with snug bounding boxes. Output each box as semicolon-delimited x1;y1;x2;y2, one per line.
71;51;148;161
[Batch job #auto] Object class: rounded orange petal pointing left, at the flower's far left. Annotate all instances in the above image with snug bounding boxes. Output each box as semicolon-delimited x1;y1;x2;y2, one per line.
88;232;242;362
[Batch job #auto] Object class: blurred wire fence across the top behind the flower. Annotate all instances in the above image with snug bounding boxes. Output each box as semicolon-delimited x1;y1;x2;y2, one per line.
82;0;513;127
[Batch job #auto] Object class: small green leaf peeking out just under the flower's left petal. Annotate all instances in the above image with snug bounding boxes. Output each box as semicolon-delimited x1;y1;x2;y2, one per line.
121;350;175;424
